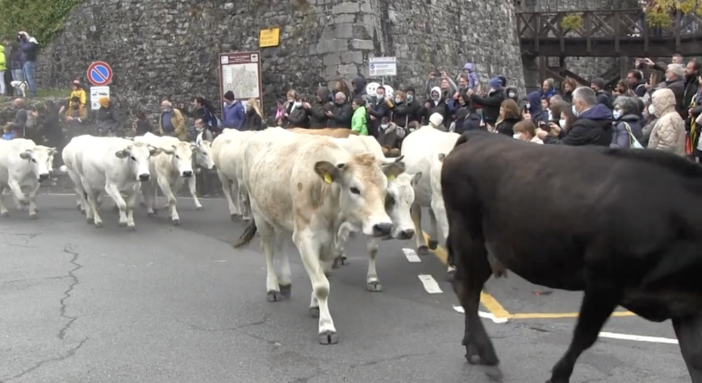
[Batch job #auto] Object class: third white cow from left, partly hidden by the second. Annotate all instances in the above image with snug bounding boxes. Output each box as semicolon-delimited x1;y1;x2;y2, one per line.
134;133;214;225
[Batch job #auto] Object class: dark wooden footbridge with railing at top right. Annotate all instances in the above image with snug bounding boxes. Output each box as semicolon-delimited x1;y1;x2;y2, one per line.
516;9;702;86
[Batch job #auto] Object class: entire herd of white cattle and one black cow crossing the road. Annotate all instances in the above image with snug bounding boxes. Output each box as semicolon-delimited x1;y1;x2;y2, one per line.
0;126;702;383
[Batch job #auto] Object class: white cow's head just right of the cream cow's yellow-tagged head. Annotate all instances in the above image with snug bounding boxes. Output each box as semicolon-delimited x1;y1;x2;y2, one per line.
385;172;422;239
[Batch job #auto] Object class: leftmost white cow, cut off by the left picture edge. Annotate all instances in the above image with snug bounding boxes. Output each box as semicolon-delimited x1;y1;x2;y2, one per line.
0;138;56;218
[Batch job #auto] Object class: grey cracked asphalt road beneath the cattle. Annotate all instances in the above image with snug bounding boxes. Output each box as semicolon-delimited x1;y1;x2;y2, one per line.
0;195;690;383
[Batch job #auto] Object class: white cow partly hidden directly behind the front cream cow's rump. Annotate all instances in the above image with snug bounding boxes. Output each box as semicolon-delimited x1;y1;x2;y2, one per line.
212;129;257;221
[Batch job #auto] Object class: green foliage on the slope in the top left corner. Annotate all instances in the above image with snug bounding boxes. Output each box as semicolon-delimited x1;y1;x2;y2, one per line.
0;0;83;47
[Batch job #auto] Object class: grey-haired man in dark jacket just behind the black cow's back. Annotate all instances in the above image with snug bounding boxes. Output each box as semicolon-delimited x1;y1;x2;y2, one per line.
536;87;613;147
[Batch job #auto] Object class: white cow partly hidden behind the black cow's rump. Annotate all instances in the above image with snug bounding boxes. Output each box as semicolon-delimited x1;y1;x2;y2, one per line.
400;126;460;278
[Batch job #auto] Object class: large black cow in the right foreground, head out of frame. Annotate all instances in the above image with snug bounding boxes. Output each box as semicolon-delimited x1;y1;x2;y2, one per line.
441;132;702;383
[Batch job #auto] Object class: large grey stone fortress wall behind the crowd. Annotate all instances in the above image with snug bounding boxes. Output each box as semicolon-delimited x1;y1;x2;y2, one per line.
38;0;524;121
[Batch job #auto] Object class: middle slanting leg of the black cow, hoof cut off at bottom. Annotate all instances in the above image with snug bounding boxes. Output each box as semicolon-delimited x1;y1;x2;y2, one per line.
547;280;622;383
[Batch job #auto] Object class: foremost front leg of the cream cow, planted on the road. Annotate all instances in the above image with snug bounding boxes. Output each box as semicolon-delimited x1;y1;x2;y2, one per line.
293;228;339;344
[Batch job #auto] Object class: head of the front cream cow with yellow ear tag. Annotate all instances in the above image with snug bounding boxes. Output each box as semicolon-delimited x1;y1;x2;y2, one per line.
314;154;405;237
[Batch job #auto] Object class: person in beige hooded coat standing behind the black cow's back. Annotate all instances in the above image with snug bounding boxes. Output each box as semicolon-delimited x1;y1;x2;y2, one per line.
648;88;685;157
